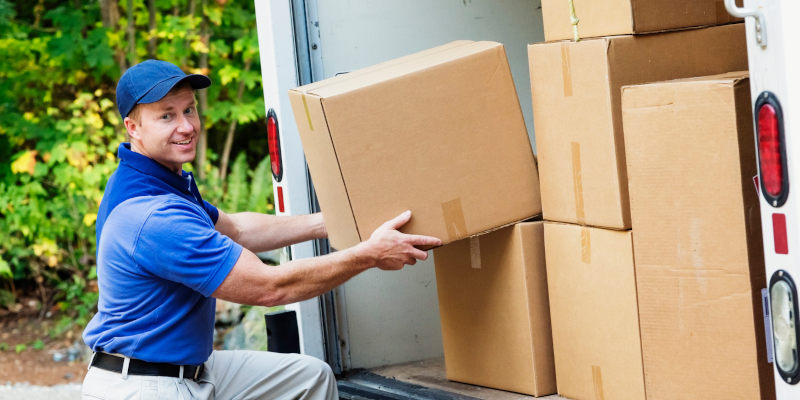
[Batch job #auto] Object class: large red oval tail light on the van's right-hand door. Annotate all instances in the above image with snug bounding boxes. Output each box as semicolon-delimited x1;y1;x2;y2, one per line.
756;92;789;207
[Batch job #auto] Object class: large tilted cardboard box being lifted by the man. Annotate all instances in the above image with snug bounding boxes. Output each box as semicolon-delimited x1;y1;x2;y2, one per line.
289;41;541;249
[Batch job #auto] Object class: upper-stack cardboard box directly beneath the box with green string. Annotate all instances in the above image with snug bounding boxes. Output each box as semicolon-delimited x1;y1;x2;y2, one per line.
528;24;747;229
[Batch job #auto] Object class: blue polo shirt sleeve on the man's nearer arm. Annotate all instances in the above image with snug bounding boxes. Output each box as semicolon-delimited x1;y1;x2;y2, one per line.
132;199;242;297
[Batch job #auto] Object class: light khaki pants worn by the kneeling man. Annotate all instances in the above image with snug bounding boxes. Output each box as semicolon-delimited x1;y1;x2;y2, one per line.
83;350;339;400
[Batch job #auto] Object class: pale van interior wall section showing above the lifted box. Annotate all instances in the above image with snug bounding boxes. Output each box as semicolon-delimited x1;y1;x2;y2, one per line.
312;0;544;151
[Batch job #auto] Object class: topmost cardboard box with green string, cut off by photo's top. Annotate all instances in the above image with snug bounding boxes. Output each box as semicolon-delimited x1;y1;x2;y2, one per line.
542;0;741;41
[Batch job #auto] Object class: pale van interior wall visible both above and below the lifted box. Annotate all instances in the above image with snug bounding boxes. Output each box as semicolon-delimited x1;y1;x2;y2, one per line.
308;0;544;369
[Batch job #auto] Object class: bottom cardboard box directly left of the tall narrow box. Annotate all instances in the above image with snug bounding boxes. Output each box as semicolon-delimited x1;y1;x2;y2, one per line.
544;222;644;400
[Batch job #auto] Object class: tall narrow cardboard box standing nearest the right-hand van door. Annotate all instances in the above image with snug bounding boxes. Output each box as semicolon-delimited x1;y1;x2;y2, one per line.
622;73;775;400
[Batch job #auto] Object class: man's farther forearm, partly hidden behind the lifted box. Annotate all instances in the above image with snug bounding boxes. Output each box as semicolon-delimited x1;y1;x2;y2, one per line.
214;210;328;253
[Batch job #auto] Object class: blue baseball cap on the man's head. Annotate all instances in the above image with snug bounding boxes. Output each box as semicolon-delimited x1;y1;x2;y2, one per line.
117;60;211;118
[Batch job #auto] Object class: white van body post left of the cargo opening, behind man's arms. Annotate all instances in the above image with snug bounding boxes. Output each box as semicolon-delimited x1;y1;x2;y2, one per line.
255;0;325;360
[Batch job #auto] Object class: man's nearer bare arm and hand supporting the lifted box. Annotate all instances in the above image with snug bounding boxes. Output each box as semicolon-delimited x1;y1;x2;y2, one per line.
211;211;442;307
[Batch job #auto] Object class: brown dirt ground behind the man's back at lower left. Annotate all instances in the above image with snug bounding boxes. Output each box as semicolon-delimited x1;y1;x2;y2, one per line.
0;313;86;386
